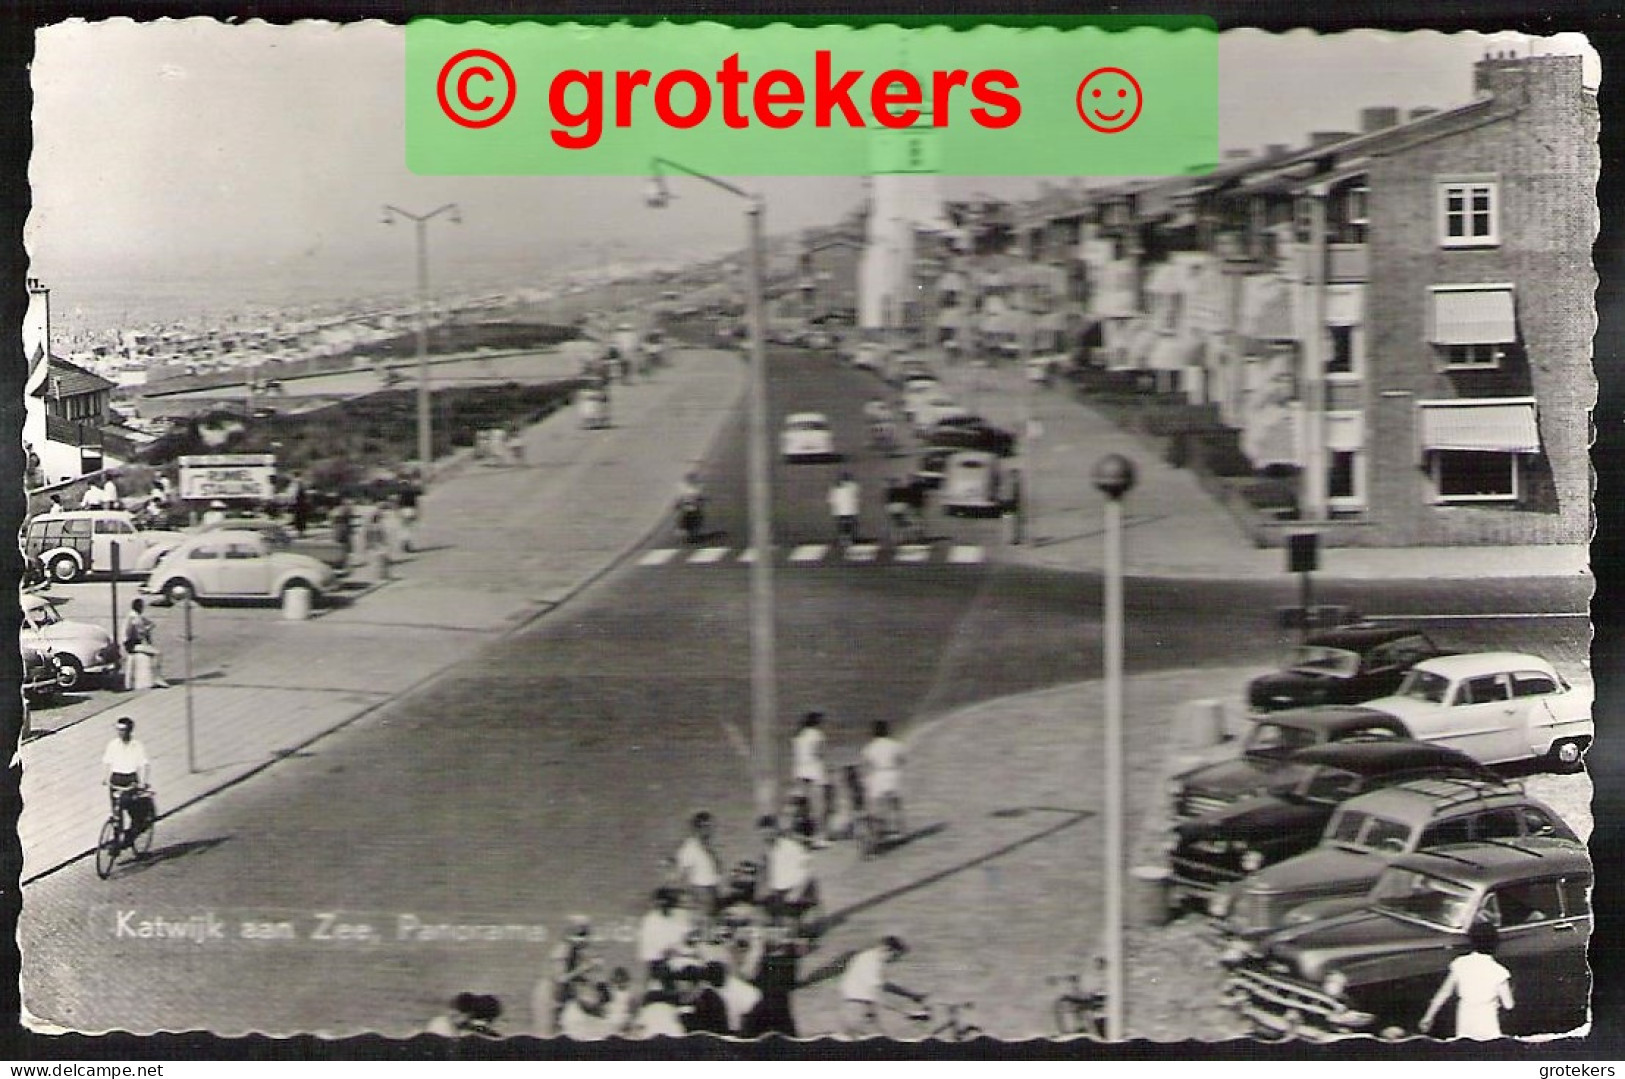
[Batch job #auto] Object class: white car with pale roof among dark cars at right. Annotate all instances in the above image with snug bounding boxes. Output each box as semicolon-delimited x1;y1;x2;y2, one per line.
1367;652;1594;772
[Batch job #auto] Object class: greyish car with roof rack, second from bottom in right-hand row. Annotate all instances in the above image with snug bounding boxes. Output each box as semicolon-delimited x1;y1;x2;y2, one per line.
1209;775;1575;936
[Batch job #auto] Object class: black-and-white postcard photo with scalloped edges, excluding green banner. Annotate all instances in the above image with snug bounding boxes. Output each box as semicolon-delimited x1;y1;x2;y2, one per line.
0;18;1619;1056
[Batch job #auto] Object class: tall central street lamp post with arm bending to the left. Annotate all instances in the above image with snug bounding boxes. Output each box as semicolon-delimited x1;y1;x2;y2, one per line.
647;158;778;816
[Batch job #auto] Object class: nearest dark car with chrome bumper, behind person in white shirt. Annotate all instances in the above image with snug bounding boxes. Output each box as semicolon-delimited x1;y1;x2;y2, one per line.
1224;837;1591;1042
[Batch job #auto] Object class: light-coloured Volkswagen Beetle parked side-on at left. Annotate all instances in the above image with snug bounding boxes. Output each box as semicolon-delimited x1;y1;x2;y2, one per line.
141;528;336;601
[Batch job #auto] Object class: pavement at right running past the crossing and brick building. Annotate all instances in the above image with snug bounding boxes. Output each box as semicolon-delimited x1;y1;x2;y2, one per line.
938;362;1589;580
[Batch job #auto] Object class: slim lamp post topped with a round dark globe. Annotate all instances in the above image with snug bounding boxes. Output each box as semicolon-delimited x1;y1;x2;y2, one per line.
1094;453;1134;1042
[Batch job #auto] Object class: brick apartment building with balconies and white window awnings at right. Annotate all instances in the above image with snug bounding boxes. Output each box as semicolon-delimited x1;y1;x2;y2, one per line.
1024;54;1599;546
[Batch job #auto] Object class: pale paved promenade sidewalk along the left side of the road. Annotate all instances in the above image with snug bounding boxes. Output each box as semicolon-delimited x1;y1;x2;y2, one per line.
18;349;746;884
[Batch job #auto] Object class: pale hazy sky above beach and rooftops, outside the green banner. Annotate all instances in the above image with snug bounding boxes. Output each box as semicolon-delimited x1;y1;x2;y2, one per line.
28;20;1597;312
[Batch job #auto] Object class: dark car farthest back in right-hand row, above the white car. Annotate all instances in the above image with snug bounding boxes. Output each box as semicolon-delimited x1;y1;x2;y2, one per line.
1246;622;1445;712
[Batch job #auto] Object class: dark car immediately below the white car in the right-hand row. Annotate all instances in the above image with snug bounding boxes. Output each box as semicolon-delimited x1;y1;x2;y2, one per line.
1170;707;1409;821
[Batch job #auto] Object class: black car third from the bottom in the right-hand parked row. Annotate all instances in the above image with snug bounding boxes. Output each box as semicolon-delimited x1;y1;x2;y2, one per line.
1168;739;1495;904
